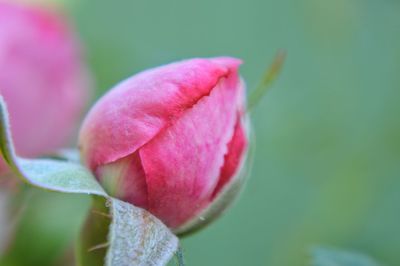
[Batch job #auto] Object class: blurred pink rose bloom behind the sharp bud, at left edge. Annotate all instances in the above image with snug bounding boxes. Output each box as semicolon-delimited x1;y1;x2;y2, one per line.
0;2;90;170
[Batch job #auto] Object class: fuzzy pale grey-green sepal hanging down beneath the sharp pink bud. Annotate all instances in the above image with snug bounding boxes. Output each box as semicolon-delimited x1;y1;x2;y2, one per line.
106;199;178;266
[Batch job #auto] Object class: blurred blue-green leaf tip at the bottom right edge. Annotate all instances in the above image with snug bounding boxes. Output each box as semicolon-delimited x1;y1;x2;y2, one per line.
311;247;381;266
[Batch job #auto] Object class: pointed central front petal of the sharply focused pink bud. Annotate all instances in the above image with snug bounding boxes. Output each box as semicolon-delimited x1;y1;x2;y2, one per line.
139;71;240;228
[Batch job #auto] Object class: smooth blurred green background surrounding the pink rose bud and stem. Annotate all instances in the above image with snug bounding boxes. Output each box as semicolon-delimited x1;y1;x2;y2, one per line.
3;0;400;266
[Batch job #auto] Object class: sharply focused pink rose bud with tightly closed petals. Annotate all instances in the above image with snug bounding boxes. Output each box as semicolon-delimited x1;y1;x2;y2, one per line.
79;58;248;233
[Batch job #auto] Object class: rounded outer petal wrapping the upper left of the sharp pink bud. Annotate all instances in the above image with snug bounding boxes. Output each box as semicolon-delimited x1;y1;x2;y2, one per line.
80;58;240;169
